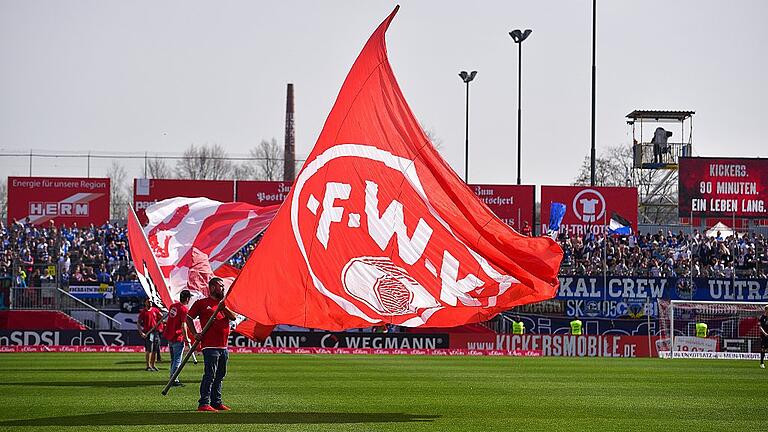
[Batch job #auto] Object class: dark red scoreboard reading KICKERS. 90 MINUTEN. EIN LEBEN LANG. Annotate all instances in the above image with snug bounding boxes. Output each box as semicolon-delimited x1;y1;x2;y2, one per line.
678;158;768;219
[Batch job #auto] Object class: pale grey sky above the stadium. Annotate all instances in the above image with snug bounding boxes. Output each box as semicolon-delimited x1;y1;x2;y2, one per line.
0;0;768;185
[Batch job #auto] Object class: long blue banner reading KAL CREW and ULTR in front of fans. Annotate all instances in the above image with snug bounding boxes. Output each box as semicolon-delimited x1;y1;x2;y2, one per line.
555;276;768;305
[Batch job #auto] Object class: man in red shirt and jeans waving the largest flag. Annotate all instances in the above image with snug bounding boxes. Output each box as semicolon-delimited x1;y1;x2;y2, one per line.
187;277;237;411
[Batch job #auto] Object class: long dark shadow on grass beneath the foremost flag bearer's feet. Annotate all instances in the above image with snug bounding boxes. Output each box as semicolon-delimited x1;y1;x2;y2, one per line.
0;411;440;429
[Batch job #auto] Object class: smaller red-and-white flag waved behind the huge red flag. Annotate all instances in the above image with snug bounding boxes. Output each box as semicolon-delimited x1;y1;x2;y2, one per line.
128;198;278;340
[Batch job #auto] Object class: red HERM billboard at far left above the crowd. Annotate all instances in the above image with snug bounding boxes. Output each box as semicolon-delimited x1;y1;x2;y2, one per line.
8;177;109;226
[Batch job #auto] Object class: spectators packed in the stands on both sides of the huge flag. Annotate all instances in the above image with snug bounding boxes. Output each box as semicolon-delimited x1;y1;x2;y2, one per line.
0;218;768;287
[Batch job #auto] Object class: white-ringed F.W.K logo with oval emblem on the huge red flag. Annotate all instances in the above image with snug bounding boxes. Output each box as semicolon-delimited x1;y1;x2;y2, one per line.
291;144;518;325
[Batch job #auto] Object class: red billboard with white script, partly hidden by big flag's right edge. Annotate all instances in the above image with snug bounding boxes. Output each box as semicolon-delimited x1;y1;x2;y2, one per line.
469;185;536;232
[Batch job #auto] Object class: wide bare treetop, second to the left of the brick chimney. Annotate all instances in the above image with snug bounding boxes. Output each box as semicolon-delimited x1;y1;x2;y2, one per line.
176;144;232;180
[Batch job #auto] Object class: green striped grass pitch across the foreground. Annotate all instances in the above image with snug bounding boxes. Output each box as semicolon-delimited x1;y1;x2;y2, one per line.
0;353;768;432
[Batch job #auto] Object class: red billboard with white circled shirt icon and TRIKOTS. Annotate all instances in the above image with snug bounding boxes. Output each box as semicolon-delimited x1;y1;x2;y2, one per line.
541;186;637;236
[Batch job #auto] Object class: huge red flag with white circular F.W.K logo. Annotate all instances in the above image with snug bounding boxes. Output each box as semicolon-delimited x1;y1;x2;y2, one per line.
231;8;562;330
